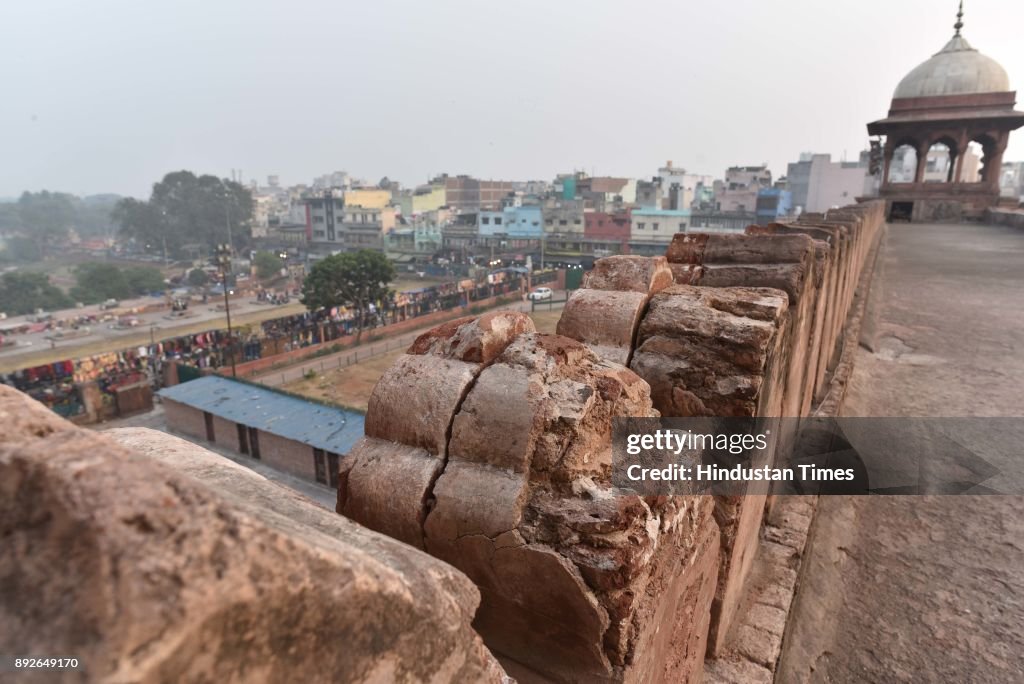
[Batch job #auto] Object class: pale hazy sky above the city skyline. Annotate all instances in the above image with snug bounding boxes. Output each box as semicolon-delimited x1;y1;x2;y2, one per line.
0;0;1024;197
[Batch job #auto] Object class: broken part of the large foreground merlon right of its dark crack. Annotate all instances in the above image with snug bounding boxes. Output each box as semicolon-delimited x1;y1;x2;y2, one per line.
417;333;719;682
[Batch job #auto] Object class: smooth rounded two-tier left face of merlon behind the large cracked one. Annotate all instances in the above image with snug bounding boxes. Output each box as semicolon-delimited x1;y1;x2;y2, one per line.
557;256;673;365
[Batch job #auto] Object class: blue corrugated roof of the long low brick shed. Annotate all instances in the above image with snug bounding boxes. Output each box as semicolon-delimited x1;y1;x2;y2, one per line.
159;375;364;454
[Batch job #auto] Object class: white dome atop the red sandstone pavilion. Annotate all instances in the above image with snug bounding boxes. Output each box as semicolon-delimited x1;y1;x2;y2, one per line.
893;34;1010;99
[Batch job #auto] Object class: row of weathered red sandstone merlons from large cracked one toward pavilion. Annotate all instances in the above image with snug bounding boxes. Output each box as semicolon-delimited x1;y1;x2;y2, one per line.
338;197;884;682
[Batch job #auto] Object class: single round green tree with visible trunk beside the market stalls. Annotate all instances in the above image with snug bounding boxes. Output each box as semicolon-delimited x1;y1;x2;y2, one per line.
302;250;395;341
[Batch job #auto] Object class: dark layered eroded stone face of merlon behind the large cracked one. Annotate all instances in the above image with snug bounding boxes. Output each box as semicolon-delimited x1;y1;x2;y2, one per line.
631;285;790;655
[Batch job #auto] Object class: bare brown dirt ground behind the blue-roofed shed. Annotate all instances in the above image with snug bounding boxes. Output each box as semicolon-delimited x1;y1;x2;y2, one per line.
281;309;561;411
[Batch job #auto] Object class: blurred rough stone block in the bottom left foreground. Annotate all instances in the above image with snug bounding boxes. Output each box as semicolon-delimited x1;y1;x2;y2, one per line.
0;386;507;682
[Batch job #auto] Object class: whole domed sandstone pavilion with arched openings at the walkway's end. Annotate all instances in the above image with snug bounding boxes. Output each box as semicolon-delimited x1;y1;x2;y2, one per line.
867;2;1024;221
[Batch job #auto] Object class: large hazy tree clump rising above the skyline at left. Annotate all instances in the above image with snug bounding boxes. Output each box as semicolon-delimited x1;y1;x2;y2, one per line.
114;171;255;257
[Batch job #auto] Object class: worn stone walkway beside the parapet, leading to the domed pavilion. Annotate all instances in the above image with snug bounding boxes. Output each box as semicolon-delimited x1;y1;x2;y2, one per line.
776;224;1024;684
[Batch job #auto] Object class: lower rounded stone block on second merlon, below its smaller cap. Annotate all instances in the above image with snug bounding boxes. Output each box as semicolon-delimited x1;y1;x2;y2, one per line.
556;290;647;365
